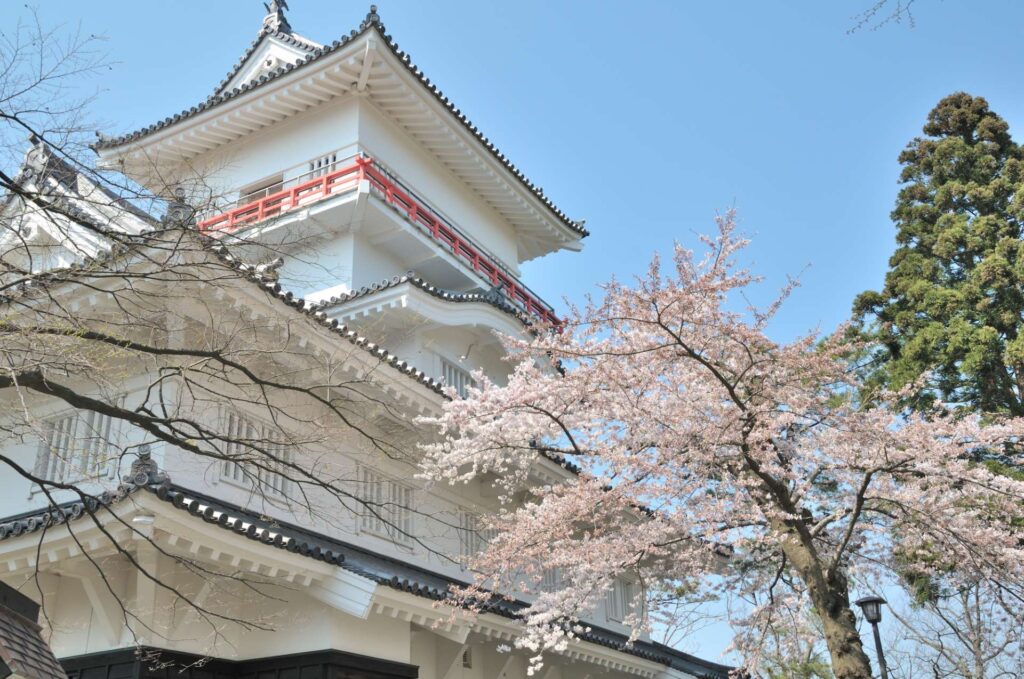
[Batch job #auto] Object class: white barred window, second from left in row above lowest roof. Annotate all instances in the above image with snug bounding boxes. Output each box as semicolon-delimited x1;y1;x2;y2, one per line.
217;411;293;499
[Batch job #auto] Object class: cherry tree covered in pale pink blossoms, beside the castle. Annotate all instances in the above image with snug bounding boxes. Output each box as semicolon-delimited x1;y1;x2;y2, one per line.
423;214;1024;679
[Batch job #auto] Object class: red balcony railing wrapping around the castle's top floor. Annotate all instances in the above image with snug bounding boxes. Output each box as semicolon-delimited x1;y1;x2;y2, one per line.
199;155;560;326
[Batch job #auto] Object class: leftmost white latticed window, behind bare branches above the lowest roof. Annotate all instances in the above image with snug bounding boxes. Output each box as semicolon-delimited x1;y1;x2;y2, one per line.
36;411;118;481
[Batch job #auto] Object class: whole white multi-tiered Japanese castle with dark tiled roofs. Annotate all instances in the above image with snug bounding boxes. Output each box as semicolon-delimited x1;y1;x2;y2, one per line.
0;6;730;679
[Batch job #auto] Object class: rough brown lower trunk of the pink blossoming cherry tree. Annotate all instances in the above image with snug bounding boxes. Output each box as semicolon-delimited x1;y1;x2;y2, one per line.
783;535;873;679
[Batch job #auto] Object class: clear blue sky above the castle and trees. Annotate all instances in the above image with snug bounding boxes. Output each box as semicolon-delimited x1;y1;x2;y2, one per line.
14;0;1024;656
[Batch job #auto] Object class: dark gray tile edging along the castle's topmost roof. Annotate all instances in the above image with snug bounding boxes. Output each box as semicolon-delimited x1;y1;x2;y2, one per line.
94;7;590;237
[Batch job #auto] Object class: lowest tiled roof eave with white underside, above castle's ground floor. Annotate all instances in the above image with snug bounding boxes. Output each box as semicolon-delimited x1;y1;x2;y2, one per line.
0;481;731;679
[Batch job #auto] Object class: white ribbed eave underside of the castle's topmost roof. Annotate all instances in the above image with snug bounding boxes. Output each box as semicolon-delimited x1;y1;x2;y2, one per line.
97;29;587;260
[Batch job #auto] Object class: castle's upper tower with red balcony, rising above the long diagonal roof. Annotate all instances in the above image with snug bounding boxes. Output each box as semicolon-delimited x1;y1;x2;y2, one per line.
97;2;587;388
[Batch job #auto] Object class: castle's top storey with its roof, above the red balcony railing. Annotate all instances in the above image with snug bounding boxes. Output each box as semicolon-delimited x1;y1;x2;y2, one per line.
96;8;587;274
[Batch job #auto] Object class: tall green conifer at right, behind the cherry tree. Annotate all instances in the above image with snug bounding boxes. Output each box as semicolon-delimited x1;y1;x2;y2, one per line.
853;92;1024;416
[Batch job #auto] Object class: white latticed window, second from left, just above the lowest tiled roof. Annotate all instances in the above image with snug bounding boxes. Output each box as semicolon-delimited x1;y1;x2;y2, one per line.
220;413;292;497
